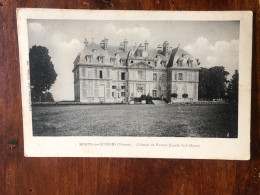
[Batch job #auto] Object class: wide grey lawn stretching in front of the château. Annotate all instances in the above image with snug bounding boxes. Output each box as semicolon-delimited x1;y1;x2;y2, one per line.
32;105;238;137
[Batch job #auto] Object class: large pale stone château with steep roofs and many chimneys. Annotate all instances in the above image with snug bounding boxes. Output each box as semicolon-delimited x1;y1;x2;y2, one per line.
73;38;200;102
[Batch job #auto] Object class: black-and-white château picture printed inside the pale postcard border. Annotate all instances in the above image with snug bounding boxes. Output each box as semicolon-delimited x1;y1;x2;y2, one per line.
16;11;251;158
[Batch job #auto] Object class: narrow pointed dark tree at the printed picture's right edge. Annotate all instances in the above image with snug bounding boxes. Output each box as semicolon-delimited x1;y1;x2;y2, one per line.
227;70;239;103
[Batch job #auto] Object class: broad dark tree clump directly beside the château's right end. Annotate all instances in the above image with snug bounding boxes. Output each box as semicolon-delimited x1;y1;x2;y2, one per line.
199;66;229;100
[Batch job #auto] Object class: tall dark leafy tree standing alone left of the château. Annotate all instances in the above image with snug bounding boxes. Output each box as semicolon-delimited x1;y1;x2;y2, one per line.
29;45;57;102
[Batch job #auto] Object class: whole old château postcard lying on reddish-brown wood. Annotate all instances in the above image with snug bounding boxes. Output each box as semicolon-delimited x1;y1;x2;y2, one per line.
17;8;252;160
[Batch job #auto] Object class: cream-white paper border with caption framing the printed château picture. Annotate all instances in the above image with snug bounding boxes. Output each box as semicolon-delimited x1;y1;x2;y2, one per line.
17;8;252;160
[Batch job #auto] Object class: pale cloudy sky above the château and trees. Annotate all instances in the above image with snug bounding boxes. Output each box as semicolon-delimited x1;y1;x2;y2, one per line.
27;19;240;101
